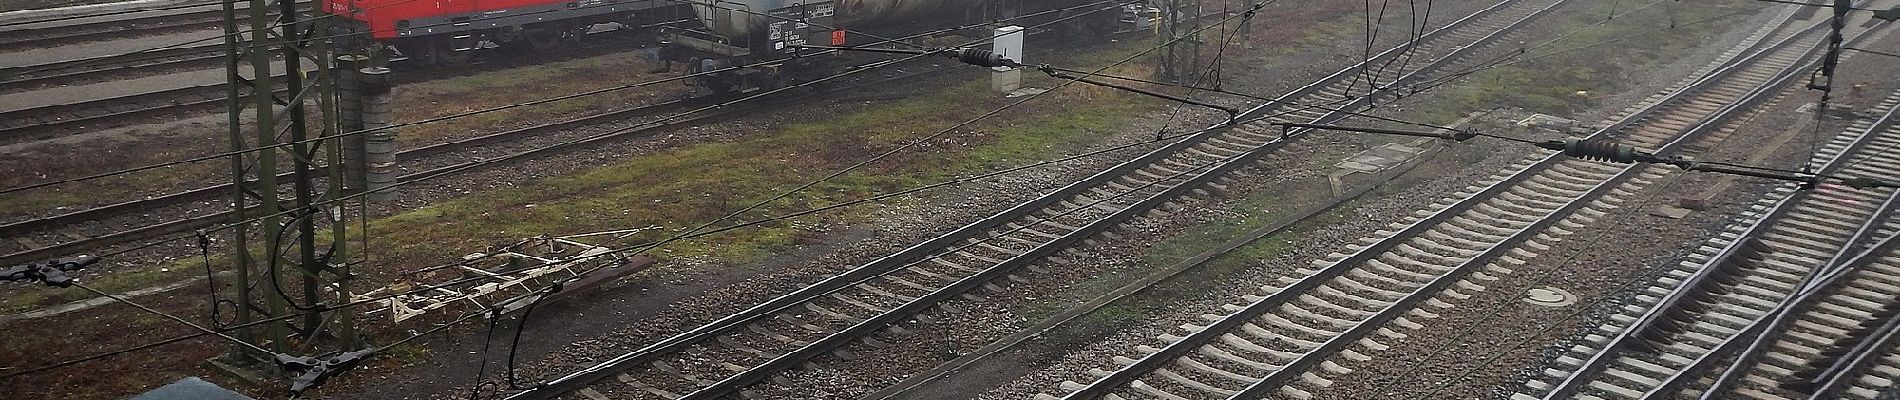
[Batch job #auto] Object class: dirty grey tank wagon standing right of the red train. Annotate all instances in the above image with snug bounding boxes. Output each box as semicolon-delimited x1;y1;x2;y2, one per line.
661;0;1148;93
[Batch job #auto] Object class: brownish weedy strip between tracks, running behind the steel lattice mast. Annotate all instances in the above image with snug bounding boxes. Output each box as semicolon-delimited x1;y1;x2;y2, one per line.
0;53;682;216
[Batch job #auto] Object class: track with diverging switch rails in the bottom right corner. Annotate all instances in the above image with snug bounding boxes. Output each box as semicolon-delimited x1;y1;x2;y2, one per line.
1514;55;1900;398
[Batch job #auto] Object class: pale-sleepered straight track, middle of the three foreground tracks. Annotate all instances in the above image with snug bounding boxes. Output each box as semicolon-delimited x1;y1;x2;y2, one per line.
1037;3;1862;398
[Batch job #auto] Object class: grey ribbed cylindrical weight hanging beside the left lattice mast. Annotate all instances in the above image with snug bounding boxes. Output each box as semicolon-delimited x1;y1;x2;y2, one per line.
361;66;397;203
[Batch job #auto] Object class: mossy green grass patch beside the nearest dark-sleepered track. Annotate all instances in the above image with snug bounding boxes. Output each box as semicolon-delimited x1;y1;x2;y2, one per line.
371;75;1153;274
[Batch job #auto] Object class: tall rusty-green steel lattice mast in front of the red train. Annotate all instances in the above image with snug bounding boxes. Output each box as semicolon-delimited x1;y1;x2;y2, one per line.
224;0;363;370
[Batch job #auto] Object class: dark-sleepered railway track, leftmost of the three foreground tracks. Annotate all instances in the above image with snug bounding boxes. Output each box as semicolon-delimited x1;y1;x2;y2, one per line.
511;0;1603;398
